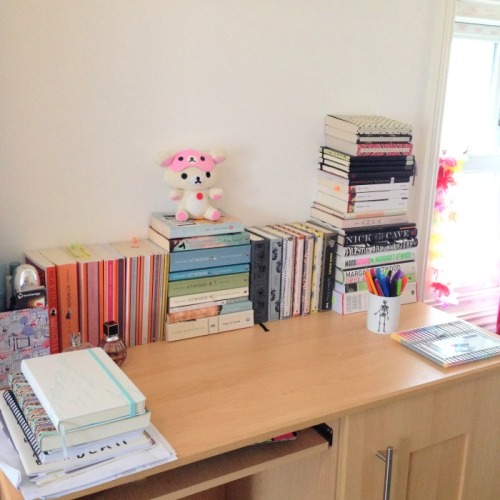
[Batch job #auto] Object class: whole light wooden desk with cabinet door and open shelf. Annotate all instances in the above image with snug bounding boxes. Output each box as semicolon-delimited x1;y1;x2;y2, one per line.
2;303;500;500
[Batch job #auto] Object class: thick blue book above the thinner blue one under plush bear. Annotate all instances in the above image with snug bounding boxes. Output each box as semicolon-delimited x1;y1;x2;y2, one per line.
170;244;251;273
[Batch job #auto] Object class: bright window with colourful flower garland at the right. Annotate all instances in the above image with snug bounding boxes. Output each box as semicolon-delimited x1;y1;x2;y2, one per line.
429;23;500;329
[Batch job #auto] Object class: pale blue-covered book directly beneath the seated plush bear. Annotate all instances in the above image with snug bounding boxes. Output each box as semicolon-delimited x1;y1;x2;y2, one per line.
150;212;244;238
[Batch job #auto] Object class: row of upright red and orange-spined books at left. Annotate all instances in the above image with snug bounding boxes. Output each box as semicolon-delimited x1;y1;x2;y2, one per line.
25;240;169;353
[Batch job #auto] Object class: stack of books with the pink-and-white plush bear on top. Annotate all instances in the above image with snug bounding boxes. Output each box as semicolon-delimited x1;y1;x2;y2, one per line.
148;213;254;341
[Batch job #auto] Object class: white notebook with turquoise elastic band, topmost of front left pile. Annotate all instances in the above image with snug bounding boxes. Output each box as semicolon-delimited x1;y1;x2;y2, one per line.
21;347;146;432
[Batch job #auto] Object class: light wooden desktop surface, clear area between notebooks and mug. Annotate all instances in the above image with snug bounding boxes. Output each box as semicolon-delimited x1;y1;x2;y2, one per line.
0;303;500;498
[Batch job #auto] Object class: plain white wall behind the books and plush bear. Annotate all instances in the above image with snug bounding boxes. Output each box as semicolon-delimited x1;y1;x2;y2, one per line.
0;0;441;266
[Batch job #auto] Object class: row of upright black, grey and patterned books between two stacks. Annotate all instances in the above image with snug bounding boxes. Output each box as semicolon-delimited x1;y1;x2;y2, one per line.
248;222;337;322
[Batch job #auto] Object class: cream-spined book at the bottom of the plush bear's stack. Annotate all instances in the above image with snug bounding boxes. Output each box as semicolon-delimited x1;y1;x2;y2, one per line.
166;310;254;342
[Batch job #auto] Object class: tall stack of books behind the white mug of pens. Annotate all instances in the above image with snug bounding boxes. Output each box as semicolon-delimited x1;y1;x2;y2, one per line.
310;115;418;314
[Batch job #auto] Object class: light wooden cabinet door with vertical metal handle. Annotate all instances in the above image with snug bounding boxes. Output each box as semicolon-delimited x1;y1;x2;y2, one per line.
337;374;500;500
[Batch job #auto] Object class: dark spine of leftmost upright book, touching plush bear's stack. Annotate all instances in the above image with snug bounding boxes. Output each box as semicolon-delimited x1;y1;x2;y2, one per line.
249;238;270;323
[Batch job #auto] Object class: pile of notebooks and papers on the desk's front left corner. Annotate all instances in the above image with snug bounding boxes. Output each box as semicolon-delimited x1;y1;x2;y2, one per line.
0;348;175;486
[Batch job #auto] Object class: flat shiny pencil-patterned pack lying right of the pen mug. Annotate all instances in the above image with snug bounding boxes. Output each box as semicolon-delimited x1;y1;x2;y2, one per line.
391;320;500;368
